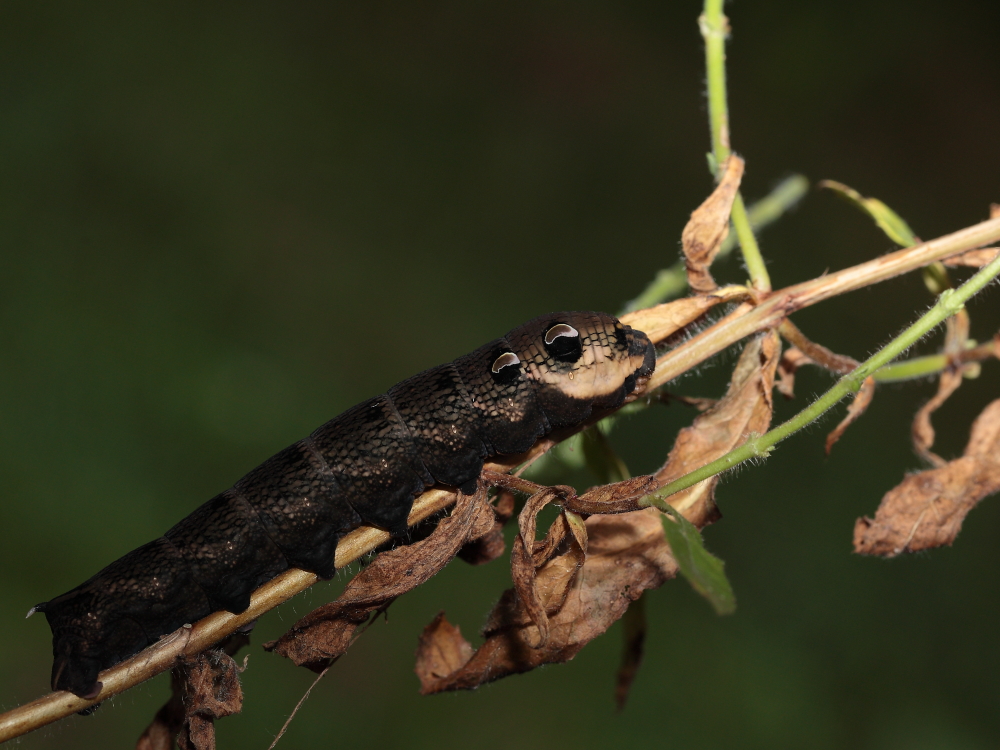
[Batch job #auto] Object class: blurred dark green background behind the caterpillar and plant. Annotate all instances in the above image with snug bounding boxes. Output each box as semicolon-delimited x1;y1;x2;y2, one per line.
0;0;1000;749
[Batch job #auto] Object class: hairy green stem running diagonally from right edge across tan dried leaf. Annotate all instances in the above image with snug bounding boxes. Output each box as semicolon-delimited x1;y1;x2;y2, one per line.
645;255;1000;506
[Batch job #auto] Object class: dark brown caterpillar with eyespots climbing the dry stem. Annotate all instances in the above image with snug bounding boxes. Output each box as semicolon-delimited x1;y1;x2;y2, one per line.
33;312;655;698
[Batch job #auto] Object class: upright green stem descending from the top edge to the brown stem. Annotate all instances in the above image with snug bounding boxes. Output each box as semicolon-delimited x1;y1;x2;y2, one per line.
698;0;771;292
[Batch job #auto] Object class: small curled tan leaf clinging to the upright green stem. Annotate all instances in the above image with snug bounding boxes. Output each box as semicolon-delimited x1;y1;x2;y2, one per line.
681;156;744;294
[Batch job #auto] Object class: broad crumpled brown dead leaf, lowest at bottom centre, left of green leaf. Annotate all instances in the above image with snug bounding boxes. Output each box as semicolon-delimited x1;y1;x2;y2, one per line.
421;509;677;694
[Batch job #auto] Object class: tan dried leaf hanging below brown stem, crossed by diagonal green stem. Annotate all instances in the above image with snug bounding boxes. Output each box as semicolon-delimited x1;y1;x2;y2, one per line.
655;331;781;526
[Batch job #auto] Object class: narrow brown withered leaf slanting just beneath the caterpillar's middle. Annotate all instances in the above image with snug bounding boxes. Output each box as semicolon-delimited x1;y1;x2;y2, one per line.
264;488;496;672
